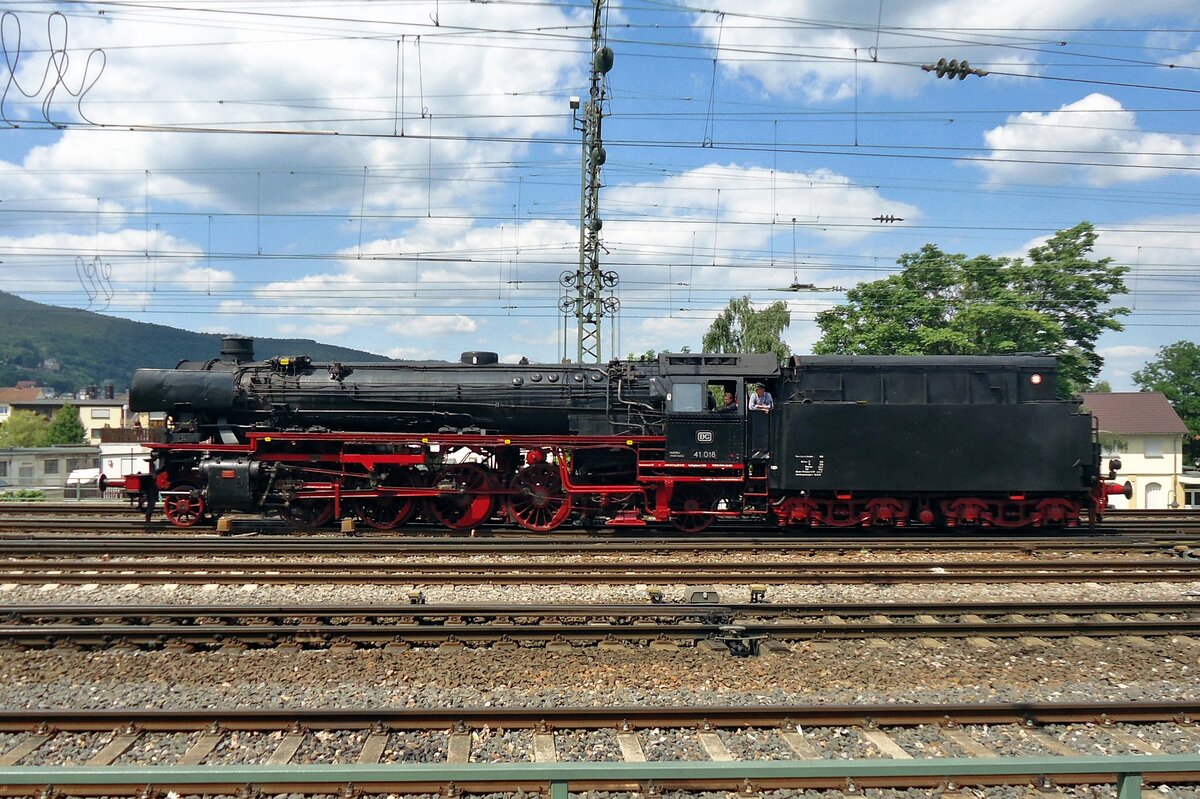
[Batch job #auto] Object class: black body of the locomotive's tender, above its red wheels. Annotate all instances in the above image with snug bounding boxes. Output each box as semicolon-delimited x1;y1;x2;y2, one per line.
772;356;1098;494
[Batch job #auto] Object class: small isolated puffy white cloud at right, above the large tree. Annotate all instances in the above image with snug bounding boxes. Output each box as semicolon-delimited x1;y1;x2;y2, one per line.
984;94;1200;186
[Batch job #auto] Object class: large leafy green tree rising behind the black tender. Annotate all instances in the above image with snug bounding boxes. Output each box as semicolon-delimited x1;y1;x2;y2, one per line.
814;222;1128;394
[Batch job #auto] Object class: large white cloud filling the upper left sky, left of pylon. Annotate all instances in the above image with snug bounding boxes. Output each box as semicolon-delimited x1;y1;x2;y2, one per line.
0;1;583;214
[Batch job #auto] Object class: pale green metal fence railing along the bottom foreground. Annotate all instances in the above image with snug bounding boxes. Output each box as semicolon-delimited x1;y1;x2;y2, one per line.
0;755;1200;799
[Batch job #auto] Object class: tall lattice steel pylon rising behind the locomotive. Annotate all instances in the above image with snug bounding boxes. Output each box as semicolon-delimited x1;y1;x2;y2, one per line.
559;0;620;364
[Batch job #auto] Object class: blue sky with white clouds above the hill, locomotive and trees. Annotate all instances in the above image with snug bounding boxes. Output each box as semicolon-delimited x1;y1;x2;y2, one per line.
0;0;1200;389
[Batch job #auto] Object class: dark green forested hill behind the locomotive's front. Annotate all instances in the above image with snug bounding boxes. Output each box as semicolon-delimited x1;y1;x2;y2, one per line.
0;292;392;391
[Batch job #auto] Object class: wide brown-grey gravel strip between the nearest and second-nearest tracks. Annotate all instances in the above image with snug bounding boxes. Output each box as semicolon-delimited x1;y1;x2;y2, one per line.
0;638;1200;709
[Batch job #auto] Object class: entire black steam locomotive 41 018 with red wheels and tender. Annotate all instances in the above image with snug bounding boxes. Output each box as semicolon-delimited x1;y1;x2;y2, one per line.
126;338;1123;531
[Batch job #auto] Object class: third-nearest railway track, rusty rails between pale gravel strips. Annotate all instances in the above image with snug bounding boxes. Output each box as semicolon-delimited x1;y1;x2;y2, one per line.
0;557;1200;585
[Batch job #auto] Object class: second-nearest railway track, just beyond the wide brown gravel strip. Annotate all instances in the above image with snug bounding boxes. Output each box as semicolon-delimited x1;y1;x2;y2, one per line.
0;601;1200;655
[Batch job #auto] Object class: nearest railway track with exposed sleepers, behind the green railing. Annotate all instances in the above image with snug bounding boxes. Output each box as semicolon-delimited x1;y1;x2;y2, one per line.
0;702;1200;797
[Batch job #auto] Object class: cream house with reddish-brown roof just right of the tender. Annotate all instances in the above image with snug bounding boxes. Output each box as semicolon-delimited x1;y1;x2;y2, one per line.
1080;391;1200;510
